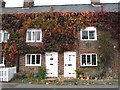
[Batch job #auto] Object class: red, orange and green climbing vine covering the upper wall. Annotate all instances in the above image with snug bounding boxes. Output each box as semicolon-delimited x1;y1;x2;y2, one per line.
2;12;120;65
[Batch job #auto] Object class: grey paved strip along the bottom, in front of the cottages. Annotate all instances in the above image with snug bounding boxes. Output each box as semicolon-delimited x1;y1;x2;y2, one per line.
2;83;118;88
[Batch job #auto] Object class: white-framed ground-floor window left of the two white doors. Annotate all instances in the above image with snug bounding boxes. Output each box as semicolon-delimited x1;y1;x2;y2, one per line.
25;54;41;66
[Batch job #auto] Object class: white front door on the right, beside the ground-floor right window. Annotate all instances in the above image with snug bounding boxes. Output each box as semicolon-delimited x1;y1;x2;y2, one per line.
64;52;76;78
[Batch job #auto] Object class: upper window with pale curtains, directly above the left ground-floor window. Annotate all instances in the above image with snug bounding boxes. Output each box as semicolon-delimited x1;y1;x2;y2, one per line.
26;29;42;42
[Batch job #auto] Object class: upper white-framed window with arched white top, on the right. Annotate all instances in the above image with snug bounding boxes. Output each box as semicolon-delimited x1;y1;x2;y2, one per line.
81;27;97;40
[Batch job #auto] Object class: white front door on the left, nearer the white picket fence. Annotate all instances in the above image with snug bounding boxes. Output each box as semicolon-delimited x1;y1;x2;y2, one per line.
45;52;58;77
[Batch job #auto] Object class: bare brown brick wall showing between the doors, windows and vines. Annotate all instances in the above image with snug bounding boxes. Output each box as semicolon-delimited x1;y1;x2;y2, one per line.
20;32;118;77
